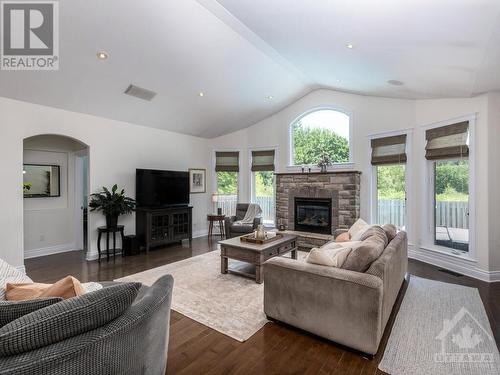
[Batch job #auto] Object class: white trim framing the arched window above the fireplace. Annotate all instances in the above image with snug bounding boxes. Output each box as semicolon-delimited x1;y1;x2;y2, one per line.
286;105;355;172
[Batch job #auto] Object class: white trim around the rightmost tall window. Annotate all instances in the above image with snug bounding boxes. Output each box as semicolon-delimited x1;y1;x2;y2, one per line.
420;113;477;262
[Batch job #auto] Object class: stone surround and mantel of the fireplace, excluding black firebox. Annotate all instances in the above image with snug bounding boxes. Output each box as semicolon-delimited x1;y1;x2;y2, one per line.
276;171;361;233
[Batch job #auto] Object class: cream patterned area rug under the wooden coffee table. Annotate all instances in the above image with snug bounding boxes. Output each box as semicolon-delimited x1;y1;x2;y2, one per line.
116;250;276;342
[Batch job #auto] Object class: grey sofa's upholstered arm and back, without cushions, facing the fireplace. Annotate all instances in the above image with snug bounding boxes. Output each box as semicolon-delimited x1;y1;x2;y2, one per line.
264;232;408;355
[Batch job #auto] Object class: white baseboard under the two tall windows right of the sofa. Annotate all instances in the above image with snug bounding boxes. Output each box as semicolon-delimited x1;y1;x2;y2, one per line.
408;246;500;283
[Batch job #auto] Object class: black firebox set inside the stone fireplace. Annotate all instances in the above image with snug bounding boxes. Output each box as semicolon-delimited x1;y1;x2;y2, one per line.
294;197;332;234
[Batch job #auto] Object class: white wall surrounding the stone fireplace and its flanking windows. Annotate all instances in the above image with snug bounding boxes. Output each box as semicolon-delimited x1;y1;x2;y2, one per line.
212;90;500;278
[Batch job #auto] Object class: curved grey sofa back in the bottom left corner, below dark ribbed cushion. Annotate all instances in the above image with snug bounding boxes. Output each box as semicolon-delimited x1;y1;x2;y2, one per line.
0;275;173;375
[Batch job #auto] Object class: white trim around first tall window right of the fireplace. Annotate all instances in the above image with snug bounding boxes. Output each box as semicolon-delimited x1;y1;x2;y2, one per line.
367;129;414;238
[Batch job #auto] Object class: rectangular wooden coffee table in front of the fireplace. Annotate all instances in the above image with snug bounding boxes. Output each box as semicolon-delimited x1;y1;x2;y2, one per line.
219;234;297;284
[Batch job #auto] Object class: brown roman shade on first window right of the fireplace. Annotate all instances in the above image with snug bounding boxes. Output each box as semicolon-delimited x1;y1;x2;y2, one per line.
371;134;406;165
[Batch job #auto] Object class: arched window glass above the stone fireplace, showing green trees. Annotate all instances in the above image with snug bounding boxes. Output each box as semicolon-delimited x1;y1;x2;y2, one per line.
290;109;351;165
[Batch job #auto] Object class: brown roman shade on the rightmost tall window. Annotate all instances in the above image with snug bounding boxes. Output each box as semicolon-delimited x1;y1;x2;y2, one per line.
425;121;469;160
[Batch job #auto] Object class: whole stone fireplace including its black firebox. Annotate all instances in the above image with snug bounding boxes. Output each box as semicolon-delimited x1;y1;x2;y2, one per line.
276;171;361;234
